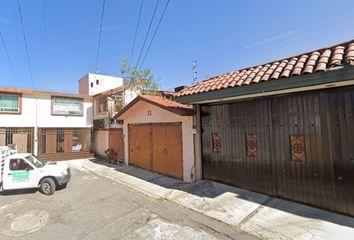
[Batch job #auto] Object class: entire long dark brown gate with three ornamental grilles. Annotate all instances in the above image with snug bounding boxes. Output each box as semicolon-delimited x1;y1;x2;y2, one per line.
201;89;354;215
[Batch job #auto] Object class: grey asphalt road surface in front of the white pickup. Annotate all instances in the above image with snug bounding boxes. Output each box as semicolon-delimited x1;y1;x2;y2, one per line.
0;164;254;240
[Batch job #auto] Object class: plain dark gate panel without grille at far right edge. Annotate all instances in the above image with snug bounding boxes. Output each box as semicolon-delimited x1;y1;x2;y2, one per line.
326;89;354;216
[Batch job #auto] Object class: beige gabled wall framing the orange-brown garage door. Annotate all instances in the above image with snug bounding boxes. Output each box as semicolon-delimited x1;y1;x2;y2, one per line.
120;101;195;182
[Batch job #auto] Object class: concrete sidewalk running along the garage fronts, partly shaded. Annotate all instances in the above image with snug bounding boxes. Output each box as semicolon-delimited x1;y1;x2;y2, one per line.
70;160;354;240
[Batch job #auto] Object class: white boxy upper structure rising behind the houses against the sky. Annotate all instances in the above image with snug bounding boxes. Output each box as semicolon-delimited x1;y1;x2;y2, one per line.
79;73;123;96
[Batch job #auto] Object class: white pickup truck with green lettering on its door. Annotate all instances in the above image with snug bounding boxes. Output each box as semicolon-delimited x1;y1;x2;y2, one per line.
0;147;71;195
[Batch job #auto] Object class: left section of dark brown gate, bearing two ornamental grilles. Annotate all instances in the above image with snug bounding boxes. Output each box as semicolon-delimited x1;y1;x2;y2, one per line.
201;100;273;194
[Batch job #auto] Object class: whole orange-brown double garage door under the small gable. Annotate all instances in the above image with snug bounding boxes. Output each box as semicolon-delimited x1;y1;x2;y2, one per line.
128;123;183;179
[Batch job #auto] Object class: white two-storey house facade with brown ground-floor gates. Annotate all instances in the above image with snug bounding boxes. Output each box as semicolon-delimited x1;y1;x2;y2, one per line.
0;88;93;159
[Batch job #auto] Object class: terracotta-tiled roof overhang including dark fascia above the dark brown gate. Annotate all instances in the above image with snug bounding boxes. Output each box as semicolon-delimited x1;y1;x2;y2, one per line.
176;40;354;103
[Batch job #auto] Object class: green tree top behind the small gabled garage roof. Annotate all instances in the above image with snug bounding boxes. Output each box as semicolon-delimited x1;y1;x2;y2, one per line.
120;59;160;93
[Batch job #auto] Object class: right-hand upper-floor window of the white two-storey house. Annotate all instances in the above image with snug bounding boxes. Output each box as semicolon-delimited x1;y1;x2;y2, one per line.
52;97;83;116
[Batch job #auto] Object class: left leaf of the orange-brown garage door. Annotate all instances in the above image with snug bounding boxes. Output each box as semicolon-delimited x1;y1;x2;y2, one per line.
128;124;152;170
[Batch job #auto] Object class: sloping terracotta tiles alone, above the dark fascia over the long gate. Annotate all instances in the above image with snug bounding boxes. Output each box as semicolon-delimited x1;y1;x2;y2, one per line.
176;39;354;97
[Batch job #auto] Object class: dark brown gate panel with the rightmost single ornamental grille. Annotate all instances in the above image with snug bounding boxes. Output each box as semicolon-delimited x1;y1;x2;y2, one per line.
272;92;334;209
